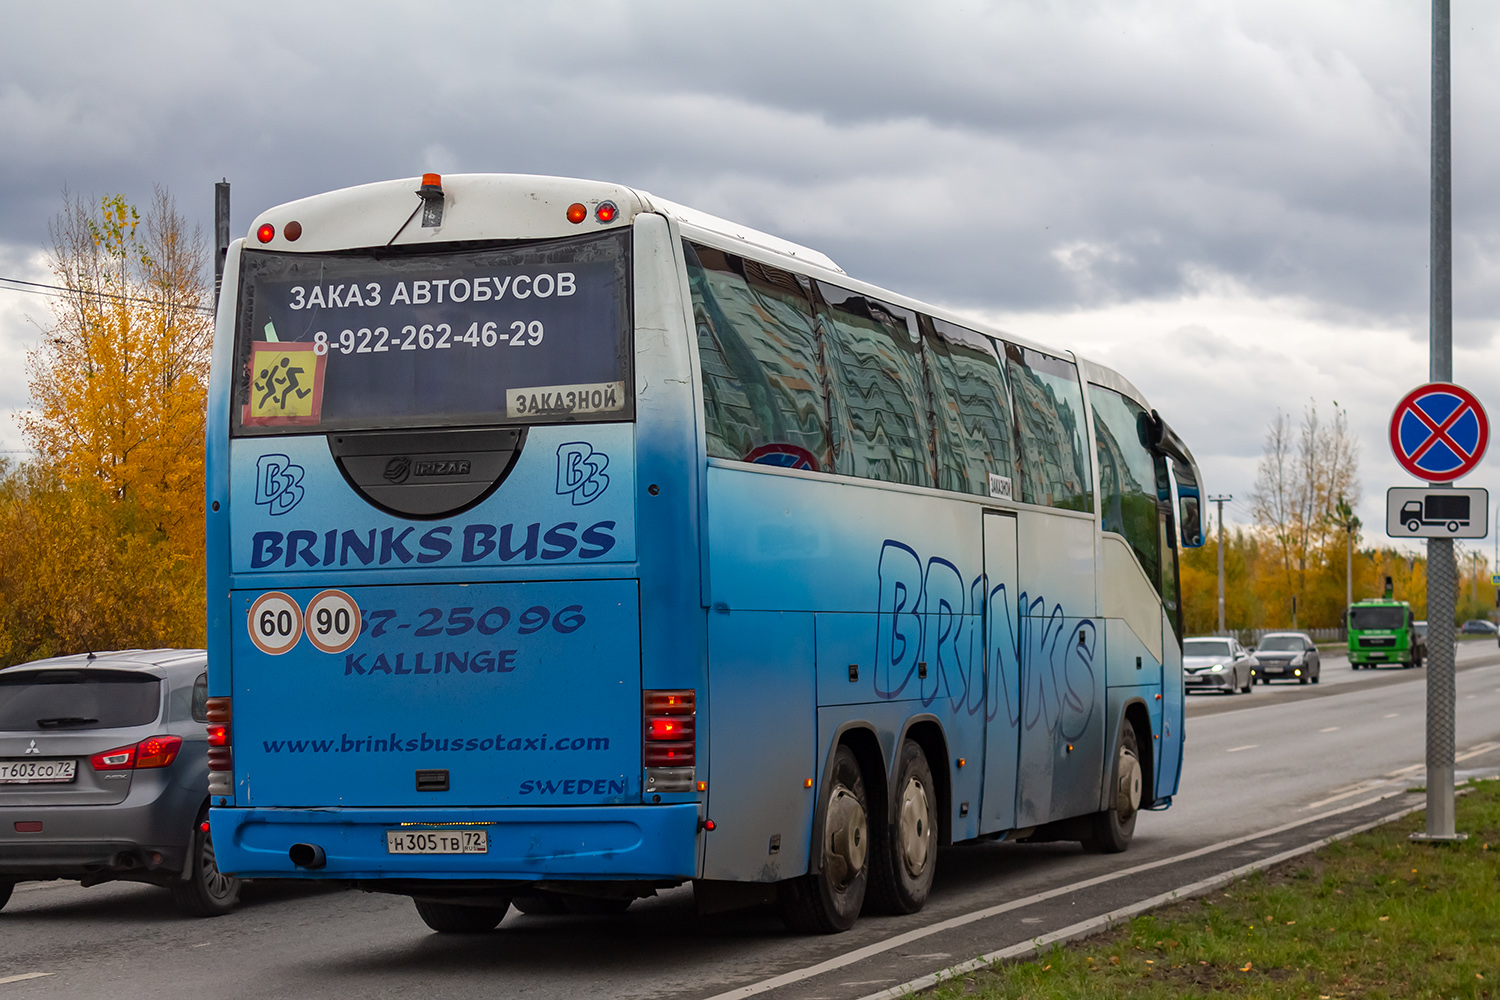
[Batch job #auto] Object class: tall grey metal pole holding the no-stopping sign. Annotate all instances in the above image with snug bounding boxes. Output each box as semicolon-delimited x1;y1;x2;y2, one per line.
1412;0;1464;841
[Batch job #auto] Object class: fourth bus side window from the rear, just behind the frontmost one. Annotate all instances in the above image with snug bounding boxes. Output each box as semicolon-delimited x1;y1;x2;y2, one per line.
1005;343;1094;511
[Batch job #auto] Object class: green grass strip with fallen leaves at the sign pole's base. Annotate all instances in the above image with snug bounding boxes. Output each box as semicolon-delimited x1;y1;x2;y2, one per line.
924;780;1500;1000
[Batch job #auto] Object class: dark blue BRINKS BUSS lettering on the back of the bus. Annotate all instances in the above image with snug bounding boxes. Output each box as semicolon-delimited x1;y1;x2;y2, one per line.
251;520;617;570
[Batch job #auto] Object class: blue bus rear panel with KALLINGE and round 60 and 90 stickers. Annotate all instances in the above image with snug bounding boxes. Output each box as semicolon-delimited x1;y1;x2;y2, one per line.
231;580;641;807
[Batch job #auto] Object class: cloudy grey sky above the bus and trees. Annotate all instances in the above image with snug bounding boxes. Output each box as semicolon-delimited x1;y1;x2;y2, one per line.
0;0;1500;550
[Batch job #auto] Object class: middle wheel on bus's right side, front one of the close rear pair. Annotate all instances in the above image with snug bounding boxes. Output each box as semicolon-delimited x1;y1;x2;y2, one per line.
866;739;938;913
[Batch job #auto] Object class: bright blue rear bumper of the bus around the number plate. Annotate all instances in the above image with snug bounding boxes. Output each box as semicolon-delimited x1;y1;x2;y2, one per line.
209;802;699;880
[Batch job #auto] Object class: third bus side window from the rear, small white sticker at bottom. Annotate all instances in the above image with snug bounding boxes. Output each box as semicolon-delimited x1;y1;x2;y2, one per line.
927;319;1020;499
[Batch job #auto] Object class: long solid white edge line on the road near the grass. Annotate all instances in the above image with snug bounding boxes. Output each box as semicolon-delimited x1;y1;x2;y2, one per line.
707;792;1424;1000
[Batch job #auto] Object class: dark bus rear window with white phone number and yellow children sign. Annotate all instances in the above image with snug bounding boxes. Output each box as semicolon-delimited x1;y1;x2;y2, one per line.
234;231;635;435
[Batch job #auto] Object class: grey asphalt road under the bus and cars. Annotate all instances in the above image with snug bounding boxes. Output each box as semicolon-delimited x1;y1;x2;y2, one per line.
0;642;1500;1000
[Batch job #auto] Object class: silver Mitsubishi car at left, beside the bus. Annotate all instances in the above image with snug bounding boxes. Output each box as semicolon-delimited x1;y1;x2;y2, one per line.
0;649;240;916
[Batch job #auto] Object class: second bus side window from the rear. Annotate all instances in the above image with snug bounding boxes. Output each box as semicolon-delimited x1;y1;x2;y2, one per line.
818;282;933;486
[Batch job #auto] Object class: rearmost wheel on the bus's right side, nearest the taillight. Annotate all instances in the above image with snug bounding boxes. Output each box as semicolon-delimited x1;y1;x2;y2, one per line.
777;747;870;934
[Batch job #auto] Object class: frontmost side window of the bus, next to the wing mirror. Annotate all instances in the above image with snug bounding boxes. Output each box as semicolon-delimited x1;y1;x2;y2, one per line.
1089;385;1161;591
